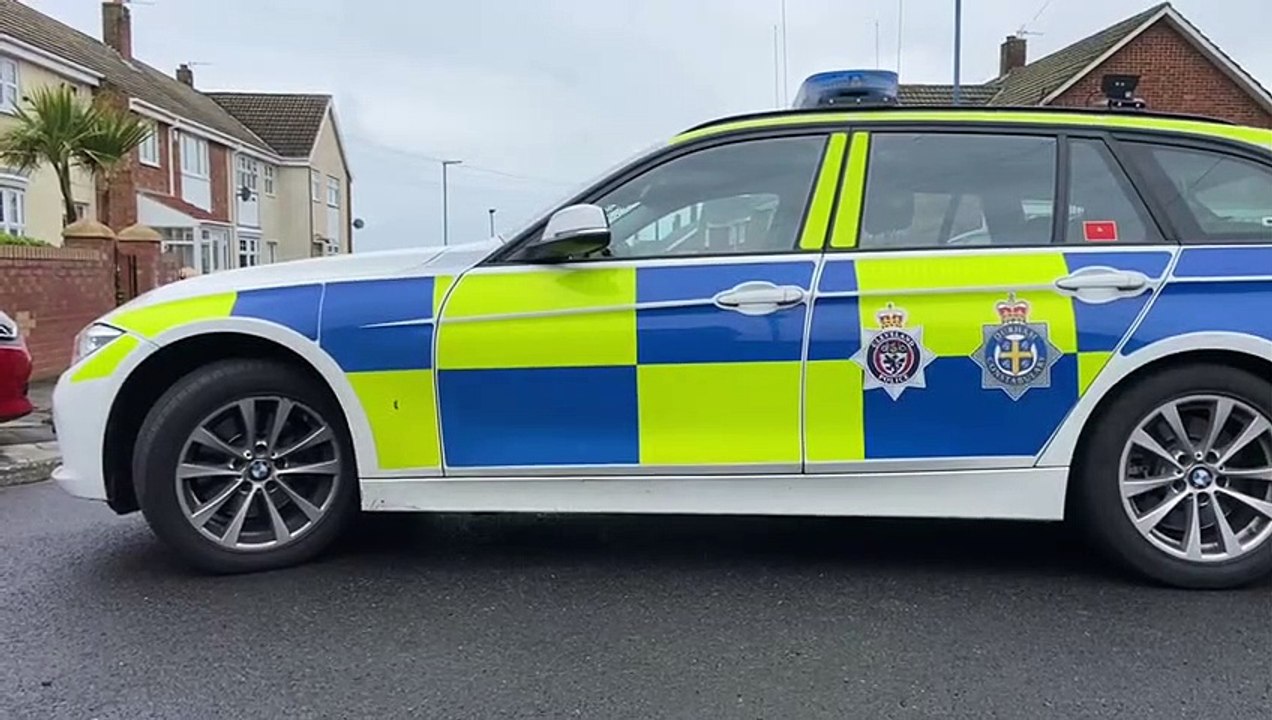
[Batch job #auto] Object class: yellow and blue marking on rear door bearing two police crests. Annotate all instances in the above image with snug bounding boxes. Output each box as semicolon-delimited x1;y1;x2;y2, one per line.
805;249;1170;463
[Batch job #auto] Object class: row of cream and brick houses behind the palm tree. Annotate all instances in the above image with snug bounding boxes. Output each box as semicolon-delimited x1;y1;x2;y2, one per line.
0;0;351;272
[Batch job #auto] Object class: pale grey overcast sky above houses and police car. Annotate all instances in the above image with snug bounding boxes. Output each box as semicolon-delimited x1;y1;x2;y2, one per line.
19;0;1272;249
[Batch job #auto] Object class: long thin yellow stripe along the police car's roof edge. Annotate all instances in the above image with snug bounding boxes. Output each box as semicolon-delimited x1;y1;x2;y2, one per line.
672;109;1272;149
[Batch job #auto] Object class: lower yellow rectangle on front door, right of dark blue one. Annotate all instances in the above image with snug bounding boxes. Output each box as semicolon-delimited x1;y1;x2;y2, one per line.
636;363;800;464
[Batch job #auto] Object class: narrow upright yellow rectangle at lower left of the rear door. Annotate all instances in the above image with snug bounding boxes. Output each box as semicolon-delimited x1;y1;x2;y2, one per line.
804;360;866;462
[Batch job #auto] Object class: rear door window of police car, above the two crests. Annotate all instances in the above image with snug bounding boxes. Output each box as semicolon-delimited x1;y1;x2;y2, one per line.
857;132;1057;249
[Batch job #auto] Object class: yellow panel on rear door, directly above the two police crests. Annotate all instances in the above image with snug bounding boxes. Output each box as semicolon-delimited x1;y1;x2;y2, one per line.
856;252;1077;357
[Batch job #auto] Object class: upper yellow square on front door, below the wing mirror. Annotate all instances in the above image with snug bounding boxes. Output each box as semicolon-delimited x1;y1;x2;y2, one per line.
438;267;636;370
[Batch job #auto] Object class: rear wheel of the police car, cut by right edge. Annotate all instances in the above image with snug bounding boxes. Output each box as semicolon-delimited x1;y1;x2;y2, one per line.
1074;365;1272;588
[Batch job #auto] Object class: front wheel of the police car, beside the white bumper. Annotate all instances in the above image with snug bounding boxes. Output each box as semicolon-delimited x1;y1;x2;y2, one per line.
132;360;359;574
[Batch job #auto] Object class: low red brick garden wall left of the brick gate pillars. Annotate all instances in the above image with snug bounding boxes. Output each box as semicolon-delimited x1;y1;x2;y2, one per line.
0;246;114;379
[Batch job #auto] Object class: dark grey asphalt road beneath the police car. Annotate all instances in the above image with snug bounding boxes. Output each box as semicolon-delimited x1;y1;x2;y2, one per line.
0;483;1272;720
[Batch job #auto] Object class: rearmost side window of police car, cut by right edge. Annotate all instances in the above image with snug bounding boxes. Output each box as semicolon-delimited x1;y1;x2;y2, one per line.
1130;142;1272;242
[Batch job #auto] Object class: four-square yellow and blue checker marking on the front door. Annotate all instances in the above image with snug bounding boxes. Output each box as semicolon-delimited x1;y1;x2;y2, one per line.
438;262;815;468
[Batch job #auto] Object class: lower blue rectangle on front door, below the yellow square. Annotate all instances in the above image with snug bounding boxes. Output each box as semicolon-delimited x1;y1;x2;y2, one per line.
438;365;640;467
